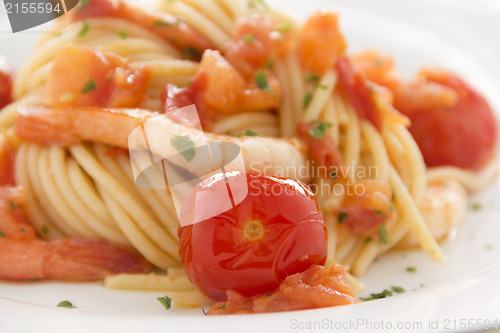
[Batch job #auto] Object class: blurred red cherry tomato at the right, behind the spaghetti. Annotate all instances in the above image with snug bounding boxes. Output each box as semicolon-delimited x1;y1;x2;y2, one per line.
399;72;498;171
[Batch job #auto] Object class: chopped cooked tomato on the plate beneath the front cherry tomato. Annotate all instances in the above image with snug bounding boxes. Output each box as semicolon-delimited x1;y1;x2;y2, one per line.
208;265;358;315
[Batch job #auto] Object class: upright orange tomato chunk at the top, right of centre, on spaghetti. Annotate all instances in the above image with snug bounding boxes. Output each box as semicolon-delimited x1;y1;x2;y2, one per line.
299;10;347;73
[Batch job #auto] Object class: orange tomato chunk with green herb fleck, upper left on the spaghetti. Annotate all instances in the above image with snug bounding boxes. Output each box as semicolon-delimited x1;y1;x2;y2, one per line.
45;45;149;107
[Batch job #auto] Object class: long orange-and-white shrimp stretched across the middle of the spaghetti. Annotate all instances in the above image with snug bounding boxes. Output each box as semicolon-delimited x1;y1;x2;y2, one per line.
15;106;309;182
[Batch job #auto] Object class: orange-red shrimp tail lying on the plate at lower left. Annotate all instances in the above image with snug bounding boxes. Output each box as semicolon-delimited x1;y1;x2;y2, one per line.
0;238;151;281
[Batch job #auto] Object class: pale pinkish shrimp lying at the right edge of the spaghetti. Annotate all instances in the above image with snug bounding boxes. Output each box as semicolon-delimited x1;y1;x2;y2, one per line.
399;181;467;247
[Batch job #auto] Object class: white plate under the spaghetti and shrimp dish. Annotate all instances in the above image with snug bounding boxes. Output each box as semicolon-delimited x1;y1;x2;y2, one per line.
0;0;500;333
